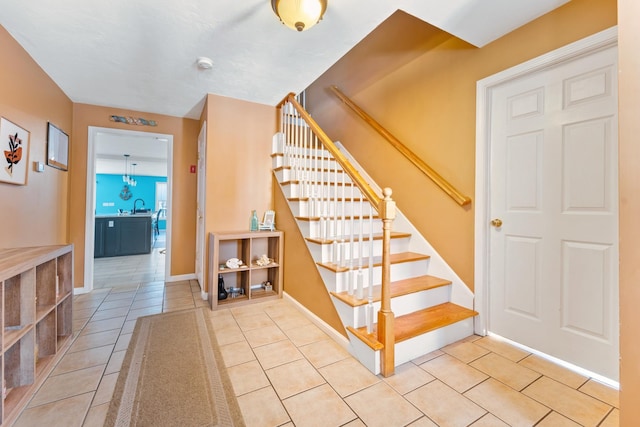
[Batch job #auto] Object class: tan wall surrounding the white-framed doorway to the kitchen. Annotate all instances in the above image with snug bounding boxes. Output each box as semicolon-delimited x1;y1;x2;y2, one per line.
69;104;200;287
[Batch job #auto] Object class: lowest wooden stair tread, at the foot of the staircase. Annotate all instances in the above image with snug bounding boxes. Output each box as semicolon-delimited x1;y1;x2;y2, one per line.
347;302;478;350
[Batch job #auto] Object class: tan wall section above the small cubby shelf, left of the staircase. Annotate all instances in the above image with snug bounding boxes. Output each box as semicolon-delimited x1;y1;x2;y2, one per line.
203;94;278;290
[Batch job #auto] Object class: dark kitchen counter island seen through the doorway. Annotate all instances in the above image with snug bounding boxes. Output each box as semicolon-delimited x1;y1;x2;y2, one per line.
93;212;153;258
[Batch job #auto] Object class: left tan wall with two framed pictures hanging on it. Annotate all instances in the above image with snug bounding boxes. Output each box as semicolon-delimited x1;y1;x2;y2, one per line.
0;26;73;248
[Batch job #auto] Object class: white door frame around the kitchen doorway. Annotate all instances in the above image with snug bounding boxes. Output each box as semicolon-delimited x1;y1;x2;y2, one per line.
81;126;173;293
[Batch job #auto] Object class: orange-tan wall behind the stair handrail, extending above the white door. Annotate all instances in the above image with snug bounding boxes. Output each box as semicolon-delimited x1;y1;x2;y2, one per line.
307;0;617;289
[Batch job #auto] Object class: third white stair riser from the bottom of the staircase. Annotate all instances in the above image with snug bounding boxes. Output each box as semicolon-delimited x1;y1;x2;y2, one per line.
318;260;429;295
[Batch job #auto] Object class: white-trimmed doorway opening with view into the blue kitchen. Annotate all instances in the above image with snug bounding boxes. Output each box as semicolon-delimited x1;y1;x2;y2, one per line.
84;126;173;292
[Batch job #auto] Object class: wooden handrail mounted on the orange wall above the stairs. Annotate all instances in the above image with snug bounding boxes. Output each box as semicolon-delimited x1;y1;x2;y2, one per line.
331;86;471;206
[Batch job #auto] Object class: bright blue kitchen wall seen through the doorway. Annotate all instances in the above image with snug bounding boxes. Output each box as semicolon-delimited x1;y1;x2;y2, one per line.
96;173;167;229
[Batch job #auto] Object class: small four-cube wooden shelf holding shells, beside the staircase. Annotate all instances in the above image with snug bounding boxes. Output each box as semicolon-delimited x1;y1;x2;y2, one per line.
209;231;284;310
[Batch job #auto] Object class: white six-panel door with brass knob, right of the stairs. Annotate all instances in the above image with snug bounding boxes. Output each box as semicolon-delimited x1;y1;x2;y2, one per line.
488;47;619;381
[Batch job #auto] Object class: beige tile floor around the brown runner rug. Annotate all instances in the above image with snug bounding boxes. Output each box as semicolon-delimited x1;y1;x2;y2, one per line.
8;247;619;427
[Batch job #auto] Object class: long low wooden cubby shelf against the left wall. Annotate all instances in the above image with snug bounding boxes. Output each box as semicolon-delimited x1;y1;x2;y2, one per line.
0;245;73;425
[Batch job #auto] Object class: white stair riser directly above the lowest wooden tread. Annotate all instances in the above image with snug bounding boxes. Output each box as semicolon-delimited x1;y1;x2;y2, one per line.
332;286;451;328
